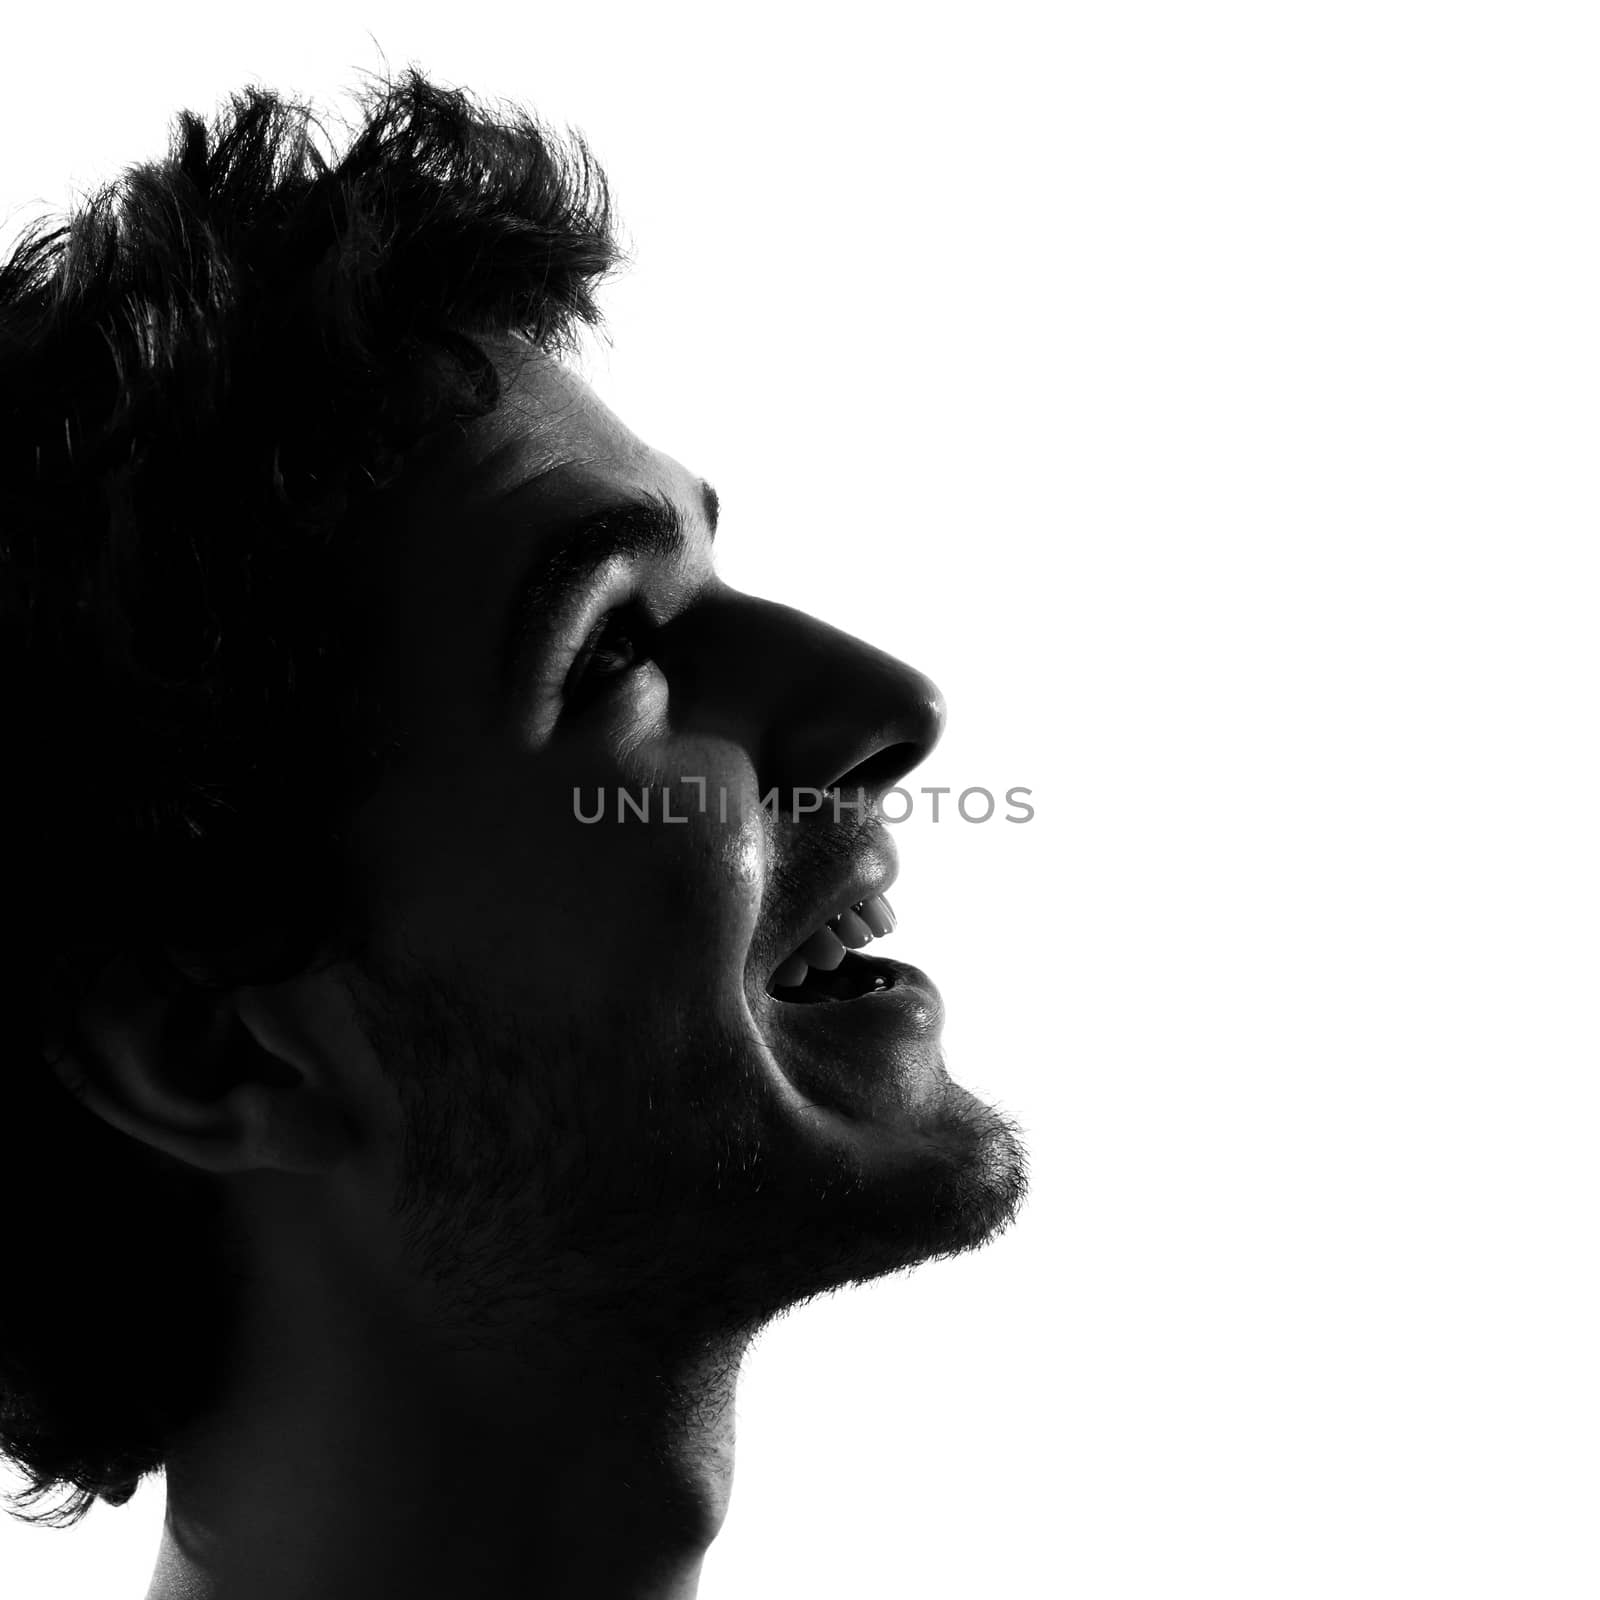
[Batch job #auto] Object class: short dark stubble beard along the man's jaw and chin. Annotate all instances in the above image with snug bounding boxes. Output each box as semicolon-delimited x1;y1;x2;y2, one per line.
344;947;1027;1352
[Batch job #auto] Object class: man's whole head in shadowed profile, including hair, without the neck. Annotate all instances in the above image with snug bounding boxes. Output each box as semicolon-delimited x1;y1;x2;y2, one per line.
0;74;1022;1536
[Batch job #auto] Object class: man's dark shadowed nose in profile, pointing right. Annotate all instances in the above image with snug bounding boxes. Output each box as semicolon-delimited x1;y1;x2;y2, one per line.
675;590;944;797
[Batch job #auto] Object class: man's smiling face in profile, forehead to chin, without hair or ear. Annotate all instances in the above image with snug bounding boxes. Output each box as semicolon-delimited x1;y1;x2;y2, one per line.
332;339;1021;1328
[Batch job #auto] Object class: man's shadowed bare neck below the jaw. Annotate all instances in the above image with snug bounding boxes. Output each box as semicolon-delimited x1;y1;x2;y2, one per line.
147;1196;741;1600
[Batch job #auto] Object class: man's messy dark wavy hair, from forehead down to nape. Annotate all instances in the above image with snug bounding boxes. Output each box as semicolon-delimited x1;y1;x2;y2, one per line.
0;69;618;1523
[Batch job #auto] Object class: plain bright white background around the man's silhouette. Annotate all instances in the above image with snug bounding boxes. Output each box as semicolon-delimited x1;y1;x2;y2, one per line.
0;0;1600;1600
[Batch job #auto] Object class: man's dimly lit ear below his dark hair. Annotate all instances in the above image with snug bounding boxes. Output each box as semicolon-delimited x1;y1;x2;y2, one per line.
50;957;366;1173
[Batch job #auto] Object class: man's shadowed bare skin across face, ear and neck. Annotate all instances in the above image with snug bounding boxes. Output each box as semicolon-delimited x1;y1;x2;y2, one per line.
59;341;1022;1600
